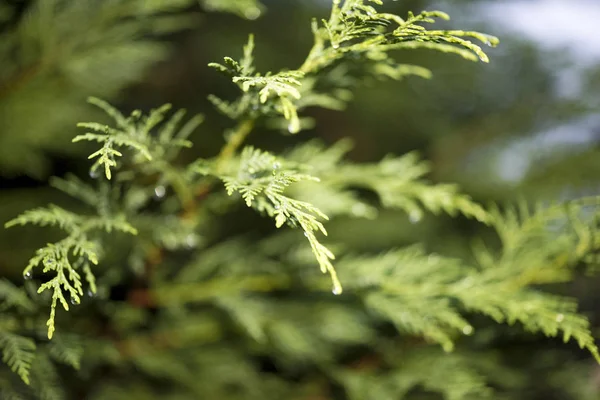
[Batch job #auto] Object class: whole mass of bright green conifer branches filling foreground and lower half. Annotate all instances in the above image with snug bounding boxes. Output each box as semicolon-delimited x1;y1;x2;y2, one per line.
0;0;600;400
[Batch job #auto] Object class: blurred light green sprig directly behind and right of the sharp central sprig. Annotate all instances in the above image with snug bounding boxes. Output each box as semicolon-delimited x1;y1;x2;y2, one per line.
288;140;491;224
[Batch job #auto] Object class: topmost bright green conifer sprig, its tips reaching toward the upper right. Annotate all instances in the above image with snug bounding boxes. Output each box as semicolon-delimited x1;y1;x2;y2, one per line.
210;0;498;133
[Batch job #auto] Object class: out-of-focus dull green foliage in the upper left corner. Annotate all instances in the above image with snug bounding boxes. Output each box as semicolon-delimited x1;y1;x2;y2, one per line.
0;0;198;176
